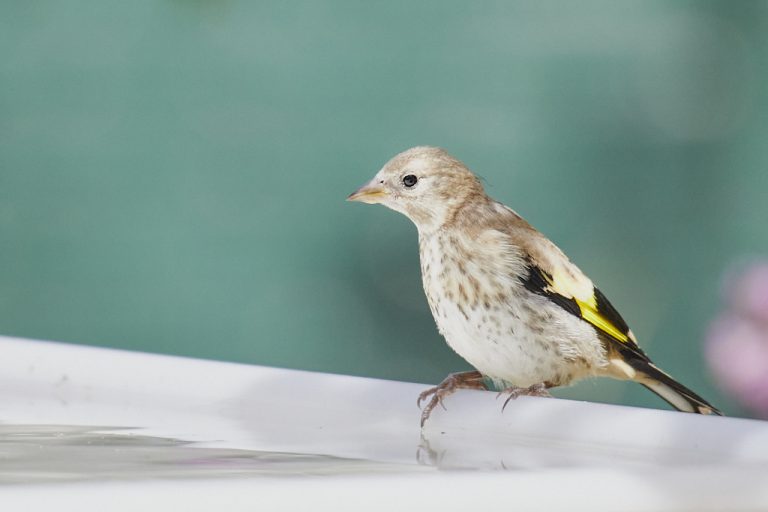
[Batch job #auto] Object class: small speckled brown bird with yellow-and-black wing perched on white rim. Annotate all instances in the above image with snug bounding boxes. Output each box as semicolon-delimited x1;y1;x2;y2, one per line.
347;146;722;427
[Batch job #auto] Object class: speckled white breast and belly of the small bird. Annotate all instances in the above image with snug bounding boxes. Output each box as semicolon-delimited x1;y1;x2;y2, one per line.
421;230;606;387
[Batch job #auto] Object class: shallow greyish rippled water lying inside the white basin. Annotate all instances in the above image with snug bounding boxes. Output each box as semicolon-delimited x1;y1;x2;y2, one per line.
0;425;426;485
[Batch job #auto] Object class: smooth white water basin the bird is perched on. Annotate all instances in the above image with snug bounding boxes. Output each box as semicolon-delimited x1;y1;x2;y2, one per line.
0;337;768;511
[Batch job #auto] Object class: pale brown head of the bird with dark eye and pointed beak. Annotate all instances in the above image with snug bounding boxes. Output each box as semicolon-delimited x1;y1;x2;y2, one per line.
347;146;485;231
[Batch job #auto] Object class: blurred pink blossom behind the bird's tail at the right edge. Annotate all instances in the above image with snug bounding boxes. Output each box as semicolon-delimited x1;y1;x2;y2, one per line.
706;262;768;419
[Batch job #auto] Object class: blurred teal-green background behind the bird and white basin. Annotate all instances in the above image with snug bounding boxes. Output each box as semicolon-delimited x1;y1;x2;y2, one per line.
0;0;768;414
